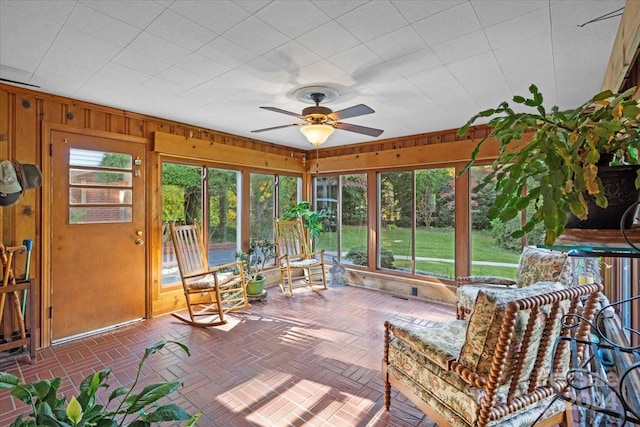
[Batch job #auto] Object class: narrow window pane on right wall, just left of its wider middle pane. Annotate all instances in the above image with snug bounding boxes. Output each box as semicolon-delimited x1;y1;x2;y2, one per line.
378;172;414;273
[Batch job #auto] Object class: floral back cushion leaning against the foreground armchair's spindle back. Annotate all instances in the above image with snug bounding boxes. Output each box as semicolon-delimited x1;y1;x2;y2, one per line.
459;282;565;381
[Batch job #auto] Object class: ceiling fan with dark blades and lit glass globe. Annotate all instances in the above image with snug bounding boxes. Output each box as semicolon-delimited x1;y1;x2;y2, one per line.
251;91;383;146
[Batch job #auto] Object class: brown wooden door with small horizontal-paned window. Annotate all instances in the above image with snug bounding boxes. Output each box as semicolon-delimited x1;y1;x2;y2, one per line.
51;131;146;341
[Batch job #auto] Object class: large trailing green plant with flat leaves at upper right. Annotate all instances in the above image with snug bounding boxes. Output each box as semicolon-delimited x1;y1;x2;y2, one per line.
458;85;640;245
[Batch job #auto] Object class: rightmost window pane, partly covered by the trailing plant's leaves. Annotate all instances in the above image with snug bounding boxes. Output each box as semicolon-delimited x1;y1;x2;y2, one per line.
470;166;522;279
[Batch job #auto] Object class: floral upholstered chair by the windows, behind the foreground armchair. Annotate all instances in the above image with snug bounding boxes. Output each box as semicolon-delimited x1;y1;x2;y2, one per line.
456;246;573;319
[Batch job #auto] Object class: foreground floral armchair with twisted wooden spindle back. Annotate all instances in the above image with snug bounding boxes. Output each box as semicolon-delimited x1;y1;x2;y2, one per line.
382;283;602;427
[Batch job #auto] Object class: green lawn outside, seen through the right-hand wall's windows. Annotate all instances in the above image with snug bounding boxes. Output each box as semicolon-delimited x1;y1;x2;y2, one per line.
320;226;520;278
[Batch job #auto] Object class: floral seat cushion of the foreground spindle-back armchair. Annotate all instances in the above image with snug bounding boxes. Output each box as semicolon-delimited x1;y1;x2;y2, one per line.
387;320;467;370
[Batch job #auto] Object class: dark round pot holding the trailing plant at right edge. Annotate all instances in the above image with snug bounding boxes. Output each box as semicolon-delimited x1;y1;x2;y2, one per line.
566;165;640;230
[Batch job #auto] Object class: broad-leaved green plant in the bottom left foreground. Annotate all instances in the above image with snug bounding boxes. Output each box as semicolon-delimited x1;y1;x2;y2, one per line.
0;341;200;427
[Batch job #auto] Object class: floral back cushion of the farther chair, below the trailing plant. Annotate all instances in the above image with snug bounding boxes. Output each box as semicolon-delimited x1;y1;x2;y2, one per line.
516;246;571;288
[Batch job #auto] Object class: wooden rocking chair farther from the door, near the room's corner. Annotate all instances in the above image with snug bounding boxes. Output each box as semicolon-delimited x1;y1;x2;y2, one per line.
273;218;327;297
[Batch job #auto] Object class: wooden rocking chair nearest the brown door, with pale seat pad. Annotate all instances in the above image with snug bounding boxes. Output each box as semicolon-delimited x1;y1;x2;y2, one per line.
169;224;251;328
